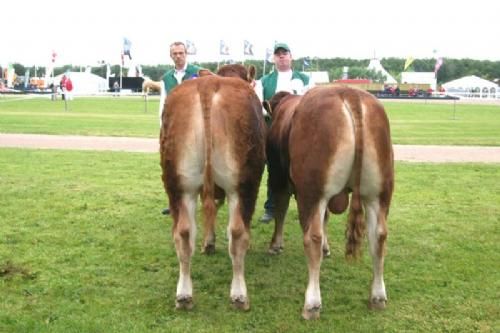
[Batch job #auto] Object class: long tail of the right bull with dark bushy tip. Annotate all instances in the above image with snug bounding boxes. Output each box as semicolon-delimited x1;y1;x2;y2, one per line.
344;92;365;258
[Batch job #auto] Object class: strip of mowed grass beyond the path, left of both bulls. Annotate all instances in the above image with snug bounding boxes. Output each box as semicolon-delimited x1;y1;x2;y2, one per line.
0;96;159;138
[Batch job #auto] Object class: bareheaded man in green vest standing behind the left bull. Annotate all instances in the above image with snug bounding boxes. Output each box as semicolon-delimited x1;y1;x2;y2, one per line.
142;42;201;215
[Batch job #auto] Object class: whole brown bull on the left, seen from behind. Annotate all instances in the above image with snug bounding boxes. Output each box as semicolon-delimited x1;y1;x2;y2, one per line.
160;72;265;309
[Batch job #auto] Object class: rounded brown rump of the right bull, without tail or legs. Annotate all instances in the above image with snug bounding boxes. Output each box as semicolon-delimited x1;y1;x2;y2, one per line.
289;87;393;202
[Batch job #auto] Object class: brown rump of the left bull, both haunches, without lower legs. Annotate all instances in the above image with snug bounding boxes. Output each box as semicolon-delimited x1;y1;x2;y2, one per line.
160;76;265;196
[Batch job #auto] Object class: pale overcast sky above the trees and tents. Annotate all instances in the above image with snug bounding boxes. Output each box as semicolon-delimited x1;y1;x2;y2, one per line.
0;0;500;66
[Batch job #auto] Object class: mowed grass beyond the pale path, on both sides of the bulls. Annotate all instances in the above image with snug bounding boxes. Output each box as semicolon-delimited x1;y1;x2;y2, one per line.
0;96;500;146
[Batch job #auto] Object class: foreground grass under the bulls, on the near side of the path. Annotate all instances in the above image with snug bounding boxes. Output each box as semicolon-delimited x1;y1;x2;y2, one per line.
0;149;500;333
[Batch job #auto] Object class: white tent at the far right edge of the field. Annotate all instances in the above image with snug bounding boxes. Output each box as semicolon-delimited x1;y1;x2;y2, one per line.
443;75;500;98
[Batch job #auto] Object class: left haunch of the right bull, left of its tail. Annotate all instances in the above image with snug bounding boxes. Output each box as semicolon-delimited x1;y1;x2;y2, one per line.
289;87;355;201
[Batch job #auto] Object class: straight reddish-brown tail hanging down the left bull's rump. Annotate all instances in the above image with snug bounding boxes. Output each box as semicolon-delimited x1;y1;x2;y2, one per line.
200;89;217;230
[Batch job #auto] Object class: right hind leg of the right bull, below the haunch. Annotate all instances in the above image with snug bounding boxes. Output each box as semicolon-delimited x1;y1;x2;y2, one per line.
365;198;388;309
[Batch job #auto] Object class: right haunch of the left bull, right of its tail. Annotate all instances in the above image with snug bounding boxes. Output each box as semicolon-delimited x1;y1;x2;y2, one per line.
208;78;265;191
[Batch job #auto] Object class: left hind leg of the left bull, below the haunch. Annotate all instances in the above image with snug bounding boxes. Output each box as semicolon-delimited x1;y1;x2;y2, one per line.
172;194;197;309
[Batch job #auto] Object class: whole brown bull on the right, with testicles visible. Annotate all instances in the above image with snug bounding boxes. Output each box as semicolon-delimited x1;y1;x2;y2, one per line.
267;86;394;319
